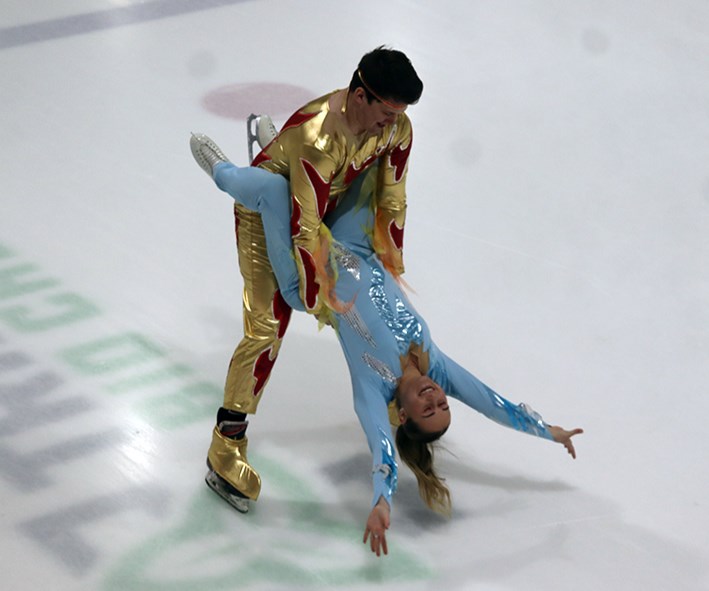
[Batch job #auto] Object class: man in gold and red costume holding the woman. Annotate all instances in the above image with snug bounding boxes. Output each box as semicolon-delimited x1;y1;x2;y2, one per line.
191;47;423;512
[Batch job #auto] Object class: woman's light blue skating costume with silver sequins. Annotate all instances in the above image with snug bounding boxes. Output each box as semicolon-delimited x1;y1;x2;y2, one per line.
214;163;552;506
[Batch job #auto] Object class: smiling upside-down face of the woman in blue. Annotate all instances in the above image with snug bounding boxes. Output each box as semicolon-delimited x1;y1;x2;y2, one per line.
399;375;451;433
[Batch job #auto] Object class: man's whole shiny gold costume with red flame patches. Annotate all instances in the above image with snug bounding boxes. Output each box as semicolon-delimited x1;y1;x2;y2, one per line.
209;91;412;498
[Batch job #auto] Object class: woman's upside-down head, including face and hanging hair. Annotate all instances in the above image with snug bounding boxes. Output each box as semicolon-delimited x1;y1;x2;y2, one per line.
396;366;451;515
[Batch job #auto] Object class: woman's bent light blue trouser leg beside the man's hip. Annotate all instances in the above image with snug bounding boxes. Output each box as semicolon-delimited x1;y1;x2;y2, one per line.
214;162;305;312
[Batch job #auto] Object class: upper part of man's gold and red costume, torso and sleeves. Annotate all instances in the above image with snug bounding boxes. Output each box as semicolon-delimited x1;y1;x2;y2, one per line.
254;91;411;312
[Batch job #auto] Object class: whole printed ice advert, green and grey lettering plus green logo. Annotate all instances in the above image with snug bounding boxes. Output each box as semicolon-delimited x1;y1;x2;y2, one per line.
0;244;434;591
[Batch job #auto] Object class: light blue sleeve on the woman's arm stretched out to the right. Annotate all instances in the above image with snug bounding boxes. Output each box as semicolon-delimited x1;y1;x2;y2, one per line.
430;349;553;440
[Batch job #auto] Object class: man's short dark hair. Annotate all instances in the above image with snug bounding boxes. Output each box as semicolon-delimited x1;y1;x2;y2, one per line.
350;46;423;105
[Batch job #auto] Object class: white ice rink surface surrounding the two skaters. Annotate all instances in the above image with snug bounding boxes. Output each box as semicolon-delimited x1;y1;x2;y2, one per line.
0;0;709;591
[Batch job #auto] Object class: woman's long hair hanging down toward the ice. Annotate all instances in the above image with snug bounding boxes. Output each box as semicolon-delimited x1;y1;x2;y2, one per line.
396;398;451;517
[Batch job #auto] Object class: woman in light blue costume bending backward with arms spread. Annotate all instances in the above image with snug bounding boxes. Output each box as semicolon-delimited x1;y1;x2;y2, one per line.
190;134;583;556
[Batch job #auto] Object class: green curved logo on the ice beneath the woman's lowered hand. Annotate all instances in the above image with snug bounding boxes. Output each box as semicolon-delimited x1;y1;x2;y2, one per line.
106;454;433;591
